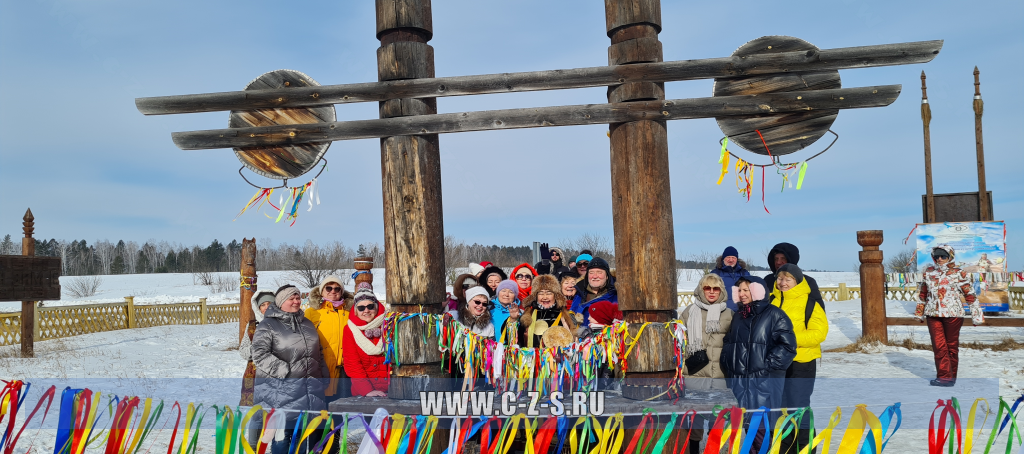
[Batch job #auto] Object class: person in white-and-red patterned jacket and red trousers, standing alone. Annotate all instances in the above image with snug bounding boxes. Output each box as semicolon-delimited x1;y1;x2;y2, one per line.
914;244;985;386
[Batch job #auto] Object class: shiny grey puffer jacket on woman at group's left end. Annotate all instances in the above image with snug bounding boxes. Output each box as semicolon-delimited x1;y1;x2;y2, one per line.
253;304;328;420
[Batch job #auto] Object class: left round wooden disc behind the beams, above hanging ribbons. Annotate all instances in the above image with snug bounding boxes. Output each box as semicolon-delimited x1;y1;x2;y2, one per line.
228;70;337;179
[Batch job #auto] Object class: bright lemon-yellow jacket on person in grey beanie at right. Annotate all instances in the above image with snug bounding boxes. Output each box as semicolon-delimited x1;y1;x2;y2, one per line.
771;279;828;363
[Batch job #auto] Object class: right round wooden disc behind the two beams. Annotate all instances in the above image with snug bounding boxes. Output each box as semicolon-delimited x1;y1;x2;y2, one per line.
715;36;842;156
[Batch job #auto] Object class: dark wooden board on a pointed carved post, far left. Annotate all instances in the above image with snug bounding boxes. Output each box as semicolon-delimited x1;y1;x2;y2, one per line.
0;209;61;358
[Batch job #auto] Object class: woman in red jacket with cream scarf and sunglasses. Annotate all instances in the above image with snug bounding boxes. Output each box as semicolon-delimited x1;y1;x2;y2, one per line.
341;283;389;398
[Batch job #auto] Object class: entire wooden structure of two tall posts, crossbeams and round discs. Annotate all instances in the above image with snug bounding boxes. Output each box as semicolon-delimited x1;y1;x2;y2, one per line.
135;0;942;399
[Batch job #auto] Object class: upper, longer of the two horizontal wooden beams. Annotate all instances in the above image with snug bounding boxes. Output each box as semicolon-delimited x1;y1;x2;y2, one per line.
135;40;942;115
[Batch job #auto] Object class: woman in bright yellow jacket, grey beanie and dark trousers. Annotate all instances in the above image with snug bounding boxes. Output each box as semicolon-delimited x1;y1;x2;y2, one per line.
771;263;828;452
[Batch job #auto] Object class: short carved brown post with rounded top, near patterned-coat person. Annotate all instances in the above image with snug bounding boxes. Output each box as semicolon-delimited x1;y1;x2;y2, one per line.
857;231;889;342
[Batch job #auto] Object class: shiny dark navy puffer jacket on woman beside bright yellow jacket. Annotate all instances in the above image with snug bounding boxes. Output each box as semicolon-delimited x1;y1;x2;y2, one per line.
721;277;797;409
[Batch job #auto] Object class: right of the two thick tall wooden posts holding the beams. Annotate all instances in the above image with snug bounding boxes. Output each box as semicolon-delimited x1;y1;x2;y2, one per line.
604;0;677;399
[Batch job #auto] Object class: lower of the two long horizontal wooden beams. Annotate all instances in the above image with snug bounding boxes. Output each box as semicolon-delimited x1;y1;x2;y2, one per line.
171;85;901;150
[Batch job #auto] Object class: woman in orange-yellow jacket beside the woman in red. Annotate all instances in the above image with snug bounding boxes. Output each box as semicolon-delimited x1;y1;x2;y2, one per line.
305;276;352;403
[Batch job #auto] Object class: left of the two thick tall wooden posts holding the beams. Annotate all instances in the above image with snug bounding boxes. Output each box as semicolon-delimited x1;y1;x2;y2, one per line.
376;0;447;399
